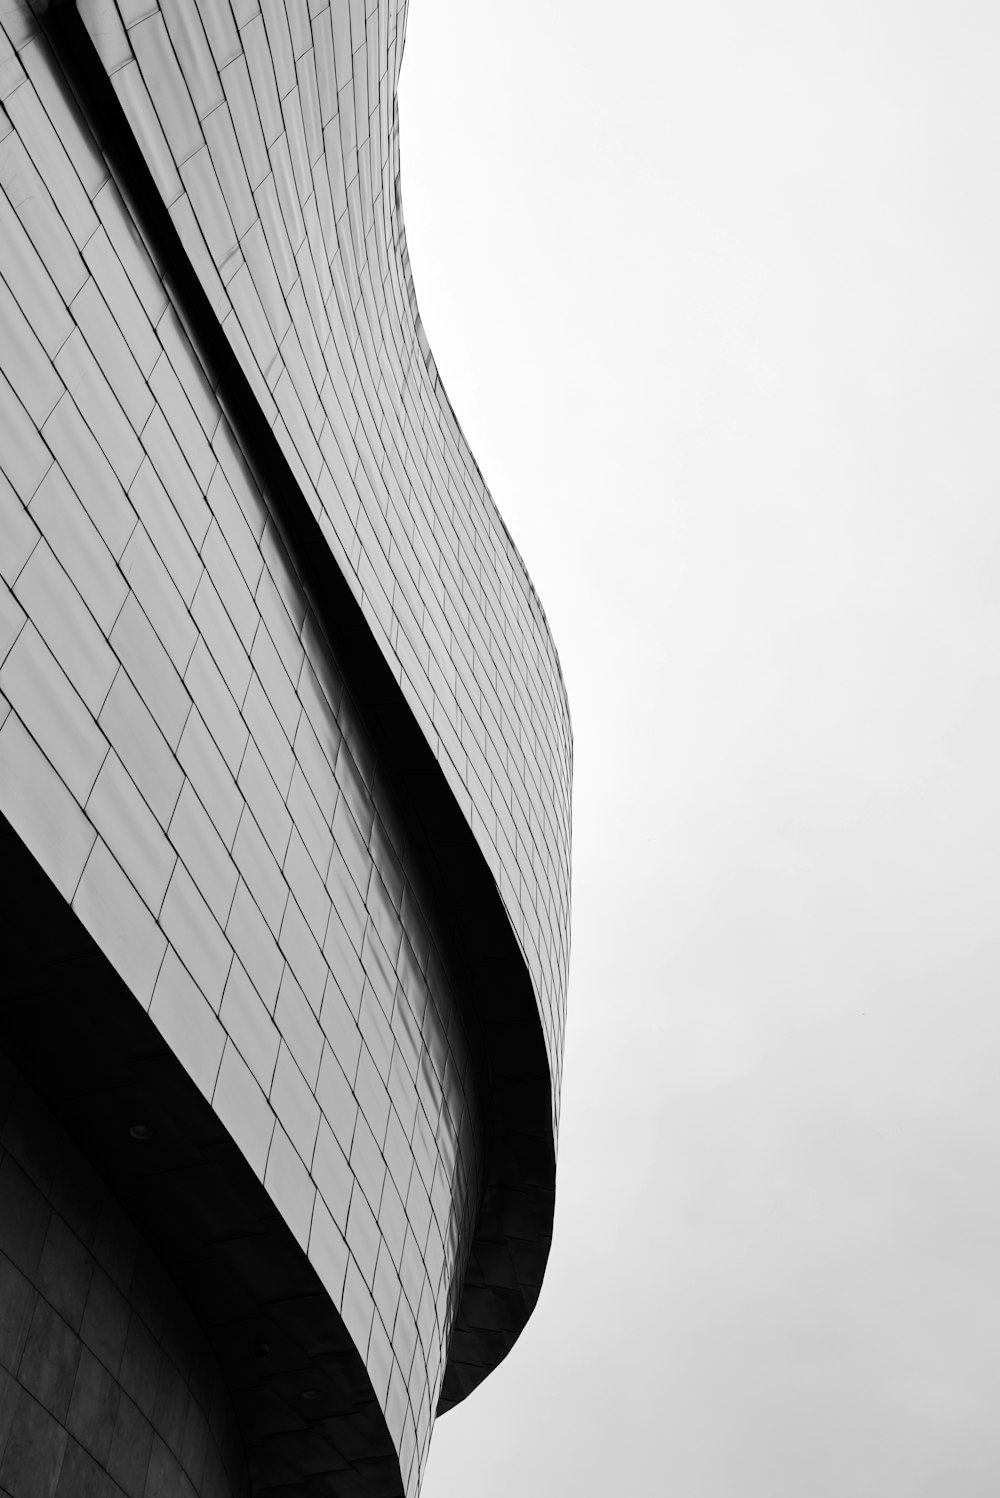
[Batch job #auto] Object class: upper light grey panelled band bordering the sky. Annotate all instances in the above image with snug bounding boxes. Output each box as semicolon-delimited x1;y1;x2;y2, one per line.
81;0;572;1115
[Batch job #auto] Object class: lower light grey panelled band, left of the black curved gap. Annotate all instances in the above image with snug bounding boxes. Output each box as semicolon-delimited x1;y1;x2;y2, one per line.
0;8;481;1489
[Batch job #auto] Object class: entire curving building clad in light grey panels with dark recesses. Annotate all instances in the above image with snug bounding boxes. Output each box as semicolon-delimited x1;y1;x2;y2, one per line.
0;0;572;1498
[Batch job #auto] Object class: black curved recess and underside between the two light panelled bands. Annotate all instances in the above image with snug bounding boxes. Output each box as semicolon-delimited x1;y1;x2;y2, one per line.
33;0;555;1410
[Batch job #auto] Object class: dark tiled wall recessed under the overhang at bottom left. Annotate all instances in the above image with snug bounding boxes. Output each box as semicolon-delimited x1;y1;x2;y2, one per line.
0;1055;249;1498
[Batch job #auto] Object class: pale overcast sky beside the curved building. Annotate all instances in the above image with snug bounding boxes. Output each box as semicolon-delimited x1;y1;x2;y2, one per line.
401;0;1000;1498
